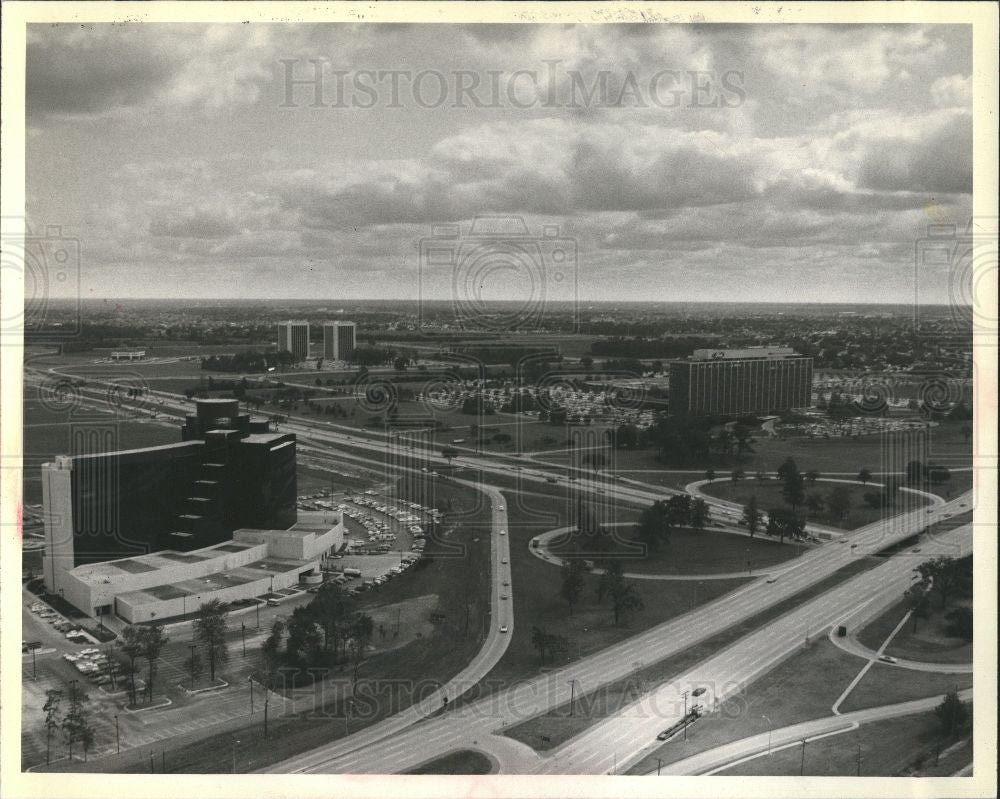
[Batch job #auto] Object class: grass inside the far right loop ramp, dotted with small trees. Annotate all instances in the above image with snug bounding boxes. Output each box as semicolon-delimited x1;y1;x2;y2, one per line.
701;479;928;530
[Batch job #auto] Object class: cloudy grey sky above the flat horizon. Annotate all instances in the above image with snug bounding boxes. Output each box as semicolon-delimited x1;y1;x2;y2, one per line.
27;24;972;302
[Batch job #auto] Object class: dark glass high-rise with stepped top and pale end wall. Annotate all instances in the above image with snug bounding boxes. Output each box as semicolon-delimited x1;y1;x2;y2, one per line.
42;399;297;582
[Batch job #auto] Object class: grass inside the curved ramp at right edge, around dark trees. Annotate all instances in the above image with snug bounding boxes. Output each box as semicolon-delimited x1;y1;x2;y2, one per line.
858;597;972;663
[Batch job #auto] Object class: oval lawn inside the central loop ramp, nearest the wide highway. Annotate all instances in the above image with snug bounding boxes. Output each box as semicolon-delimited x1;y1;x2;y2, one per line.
550;527;798;574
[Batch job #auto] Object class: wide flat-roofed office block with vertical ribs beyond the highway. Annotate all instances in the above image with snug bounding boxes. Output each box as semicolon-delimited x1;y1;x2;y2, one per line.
669;347;812;416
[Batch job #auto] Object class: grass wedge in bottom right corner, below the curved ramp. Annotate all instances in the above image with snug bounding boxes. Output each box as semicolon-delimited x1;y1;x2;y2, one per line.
719;712;972;777
